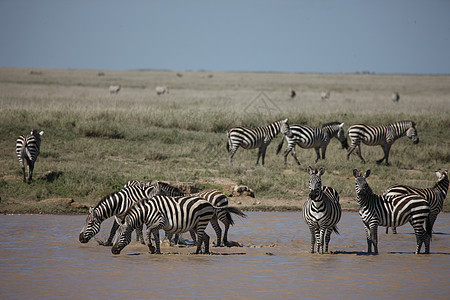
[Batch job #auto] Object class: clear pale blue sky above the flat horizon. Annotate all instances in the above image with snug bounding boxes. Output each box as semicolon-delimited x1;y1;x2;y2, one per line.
0;0;450;74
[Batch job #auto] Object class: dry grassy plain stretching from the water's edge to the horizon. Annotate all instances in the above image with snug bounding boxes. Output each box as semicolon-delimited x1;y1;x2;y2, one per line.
0;68;450;213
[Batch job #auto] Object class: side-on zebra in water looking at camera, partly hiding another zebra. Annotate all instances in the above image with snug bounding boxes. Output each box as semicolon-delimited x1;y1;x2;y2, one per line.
353;169;431;254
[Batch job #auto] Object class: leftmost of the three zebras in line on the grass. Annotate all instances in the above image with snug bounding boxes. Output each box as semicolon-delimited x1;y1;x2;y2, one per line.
227;119;290;165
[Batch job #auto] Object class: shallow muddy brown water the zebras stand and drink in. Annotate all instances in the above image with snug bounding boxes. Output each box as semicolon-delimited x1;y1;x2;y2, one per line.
0;212;450;299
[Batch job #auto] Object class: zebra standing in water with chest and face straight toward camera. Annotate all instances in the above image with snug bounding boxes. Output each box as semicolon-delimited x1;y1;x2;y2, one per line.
303;167;342;254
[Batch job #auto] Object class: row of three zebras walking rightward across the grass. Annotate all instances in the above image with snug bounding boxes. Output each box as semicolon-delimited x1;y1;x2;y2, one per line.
227;119;419;166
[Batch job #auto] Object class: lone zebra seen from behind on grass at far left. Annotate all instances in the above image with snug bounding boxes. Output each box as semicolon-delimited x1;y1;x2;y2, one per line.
16;129;44;183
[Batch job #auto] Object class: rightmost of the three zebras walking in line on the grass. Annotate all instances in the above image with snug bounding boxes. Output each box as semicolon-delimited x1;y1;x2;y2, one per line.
347;120;419;166
